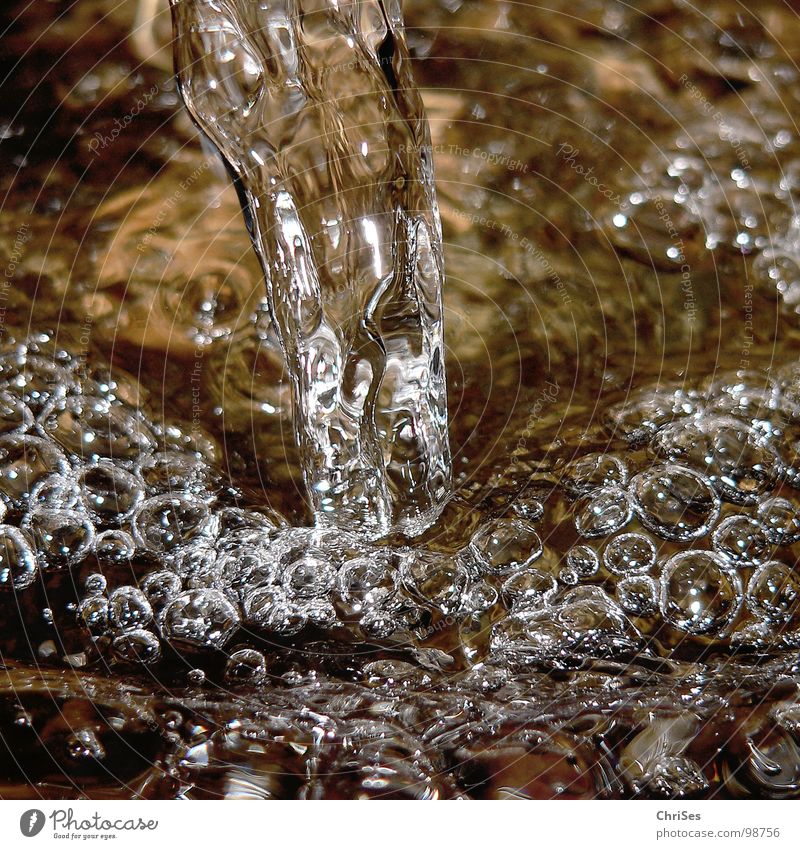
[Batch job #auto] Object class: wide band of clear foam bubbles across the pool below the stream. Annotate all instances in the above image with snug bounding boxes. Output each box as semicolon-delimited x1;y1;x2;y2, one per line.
0;335;800;685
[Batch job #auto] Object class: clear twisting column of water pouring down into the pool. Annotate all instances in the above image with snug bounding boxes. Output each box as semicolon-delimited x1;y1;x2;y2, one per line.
171;0;451;537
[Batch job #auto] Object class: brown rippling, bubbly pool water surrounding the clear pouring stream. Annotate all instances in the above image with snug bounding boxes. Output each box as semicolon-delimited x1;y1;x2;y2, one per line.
0;0;800;798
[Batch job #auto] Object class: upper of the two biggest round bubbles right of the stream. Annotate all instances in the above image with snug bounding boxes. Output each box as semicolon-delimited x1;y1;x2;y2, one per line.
630;465;720;541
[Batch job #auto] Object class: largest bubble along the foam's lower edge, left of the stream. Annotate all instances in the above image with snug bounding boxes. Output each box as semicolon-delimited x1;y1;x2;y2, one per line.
158;589;239;649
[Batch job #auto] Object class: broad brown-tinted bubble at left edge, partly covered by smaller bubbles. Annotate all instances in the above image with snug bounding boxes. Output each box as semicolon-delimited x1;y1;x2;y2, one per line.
0;434;69;511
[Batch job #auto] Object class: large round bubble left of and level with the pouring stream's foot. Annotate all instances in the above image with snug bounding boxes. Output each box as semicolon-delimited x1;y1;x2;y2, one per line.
131;494;211;555
